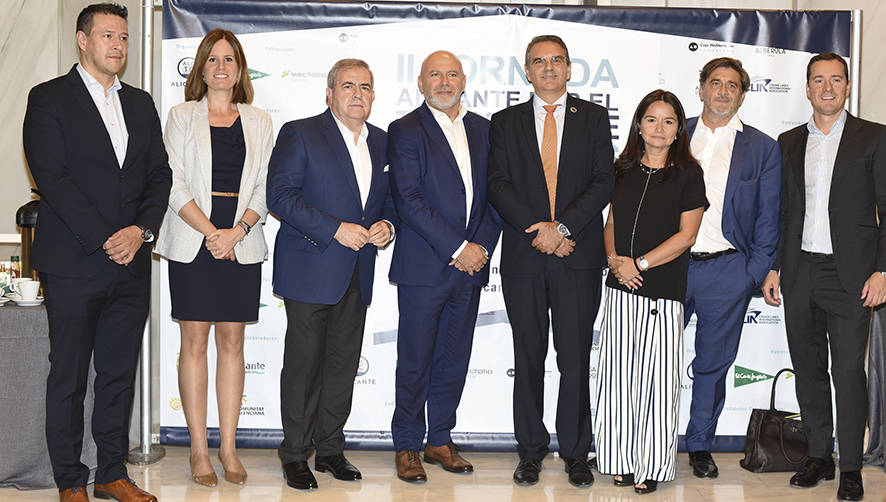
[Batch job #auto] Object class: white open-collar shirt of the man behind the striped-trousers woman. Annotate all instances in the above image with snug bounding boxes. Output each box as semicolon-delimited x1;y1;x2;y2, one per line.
690;115;744;253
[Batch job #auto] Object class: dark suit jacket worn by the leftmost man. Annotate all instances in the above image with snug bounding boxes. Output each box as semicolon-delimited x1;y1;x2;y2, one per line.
23;65;172;277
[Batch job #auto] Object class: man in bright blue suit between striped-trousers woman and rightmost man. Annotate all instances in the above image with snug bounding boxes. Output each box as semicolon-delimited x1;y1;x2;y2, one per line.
685;57;781;478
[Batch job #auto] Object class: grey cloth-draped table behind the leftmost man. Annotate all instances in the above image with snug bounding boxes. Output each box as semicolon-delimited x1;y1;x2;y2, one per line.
0;302;96;490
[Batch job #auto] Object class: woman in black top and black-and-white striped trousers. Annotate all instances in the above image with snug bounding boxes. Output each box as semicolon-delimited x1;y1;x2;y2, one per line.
594;89;708;494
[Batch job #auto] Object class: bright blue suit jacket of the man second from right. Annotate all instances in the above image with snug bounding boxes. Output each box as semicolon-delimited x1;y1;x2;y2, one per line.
686;117;781;284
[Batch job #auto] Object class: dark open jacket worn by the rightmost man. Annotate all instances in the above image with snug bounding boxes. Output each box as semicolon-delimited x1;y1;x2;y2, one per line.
773;114;886;296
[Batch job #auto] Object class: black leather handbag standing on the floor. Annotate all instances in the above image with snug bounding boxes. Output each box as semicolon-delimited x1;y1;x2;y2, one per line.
739;368;808;472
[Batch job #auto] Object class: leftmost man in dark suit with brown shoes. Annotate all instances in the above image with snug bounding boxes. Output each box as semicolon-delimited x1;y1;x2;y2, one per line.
23;4;172;502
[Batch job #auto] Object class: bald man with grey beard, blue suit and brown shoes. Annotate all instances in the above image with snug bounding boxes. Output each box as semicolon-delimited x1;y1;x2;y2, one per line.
388;51;501;481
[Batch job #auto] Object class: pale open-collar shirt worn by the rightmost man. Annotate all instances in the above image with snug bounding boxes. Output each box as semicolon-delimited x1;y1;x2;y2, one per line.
801;110;846;254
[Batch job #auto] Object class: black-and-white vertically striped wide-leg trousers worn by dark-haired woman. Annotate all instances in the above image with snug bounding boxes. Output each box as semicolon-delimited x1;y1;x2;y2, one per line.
594;288;683;484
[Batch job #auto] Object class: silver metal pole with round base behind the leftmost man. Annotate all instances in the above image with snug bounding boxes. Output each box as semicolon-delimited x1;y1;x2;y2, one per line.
127;0;166;465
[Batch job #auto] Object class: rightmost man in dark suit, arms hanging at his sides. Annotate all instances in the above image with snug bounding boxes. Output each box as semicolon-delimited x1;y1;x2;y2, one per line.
763;53;886;500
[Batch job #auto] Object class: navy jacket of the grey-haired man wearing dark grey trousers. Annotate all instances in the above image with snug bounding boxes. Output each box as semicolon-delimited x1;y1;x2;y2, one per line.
267;108;397;305
